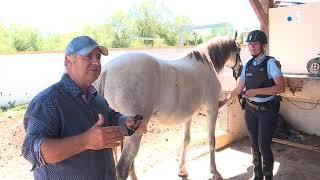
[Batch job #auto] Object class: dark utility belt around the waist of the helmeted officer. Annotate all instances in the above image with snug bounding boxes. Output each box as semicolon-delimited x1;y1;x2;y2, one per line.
240;95;282;114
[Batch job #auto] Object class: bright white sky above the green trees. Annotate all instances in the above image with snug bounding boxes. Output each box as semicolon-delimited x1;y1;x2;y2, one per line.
0;0;320;33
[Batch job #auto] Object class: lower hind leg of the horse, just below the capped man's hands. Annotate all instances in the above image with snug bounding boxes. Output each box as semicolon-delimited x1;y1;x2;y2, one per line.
117;131;142;180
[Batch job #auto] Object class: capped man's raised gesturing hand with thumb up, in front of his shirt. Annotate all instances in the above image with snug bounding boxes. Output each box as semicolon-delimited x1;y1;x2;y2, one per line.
84;114;124;150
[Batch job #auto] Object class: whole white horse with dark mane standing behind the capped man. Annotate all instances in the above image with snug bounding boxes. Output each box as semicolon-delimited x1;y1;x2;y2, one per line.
95;39;241;180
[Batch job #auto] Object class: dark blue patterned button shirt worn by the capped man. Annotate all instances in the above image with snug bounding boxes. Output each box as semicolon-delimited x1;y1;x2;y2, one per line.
22;74;126;180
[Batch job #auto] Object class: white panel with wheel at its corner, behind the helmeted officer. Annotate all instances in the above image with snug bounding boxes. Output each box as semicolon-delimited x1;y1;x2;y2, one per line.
269;2;320;76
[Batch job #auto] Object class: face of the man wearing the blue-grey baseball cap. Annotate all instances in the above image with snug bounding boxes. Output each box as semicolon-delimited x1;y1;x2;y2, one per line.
69;48;101;85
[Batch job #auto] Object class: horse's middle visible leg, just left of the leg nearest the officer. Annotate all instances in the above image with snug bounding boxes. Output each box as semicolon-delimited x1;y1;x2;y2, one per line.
179;118;192;177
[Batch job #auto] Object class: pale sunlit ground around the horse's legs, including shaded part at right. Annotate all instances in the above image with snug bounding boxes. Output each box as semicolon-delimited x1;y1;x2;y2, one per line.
0;114;320;180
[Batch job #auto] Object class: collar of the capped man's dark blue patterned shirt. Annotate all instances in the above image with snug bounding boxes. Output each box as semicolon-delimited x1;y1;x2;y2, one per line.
60;74;97;96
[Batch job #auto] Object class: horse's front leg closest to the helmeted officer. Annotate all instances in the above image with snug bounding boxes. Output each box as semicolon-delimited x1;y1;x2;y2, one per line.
208;106;222;180
